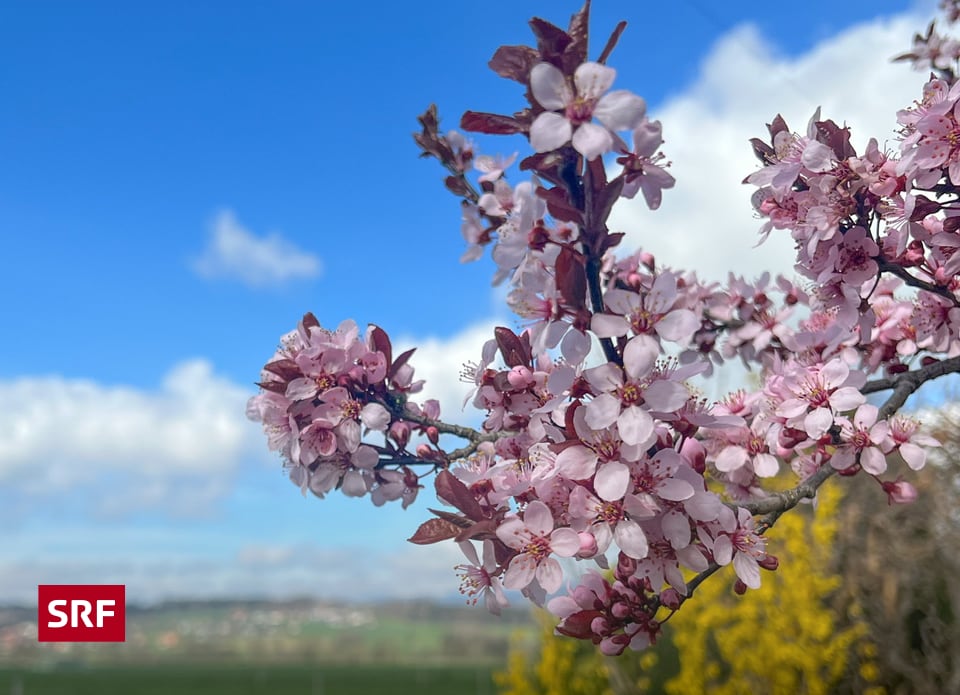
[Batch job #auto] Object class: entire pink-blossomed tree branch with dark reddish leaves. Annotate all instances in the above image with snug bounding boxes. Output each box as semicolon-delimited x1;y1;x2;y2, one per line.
250;3;960;654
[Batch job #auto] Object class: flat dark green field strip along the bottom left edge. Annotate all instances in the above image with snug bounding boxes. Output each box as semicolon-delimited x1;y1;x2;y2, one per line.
0;665;495;695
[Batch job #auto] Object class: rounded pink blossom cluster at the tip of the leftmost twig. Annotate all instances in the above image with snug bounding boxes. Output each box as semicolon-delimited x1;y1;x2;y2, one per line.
247;314;440;507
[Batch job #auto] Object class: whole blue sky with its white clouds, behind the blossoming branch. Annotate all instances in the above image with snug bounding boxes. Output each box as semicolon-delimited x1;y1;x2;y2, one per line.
0;0;932;603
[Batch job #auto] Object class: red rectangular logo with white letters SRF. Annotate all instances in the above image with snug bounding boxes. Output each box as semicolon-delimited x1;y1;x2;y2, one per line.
37;584;127;642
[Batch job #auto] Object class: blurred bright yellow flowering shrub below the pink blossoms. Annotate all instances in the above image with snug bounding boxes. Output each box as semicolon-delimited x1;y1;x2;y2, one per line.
498;484;884;695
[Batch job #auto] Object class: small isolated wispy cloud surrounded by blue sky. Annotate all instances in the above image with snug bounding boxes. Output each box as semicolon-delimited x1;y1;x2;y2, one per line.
193;210;322;287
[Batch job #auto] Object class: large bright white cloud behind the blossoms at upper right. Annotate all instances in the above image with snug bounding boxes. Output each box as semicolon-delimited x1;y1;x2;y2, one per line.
611;11;925;280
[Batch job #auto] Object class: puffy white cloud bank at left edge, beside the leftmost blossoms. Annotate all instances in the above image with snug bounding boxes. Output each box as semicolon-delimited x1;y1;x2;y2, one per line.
0;360;265;513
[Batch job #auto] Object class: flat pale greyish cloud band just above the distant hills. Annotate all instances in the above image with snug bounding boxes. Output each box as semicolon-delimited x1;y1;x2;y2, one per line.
0;530;465;603
